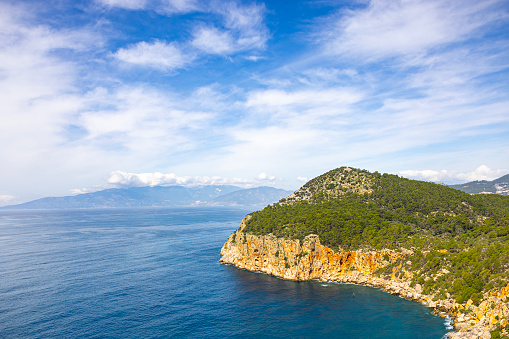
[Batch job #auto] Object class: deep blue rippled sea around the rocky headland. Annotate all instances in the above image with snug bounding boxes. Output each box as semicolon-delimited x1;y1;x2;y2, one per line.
0;207;447;339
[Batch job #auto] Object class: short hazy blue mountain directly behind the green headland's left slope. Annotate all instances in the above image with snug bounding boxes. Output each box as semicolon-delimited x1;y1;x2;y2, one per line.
207;186;293;206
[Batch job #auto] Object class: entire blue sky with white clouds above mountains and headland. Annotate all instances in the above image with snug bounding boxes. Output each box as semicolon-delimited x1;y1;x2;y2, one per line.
0;0;509;206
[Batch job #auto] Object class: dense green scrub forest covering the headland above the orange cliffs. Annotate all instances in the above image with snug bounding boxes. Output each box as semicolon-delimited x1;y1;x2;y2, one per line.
245;167;509;303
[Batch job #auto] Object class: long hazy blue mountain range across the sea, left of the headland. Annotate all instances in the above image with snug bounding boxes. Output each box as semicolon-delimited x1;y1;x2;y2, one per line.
2;185;292;209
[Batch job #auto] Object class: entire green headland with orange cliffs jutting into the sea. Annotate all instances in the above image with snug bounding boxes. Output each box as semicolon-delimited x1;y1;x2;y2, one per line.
220;167;509;338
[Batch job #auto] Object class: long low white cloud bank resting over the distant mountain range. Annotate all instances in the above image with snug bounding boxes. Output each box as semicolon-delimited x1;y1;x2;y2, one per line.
108;171;250;187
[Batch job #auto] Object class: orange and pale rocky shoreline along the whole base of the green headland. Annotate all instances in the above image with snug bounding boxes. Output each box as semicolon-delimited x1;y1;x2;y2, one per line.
220;216;509;339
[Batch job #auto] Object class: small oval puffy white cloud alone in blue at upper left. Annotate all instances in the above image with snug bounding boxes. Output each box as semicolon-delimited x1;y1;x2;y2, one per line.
113;40;193;70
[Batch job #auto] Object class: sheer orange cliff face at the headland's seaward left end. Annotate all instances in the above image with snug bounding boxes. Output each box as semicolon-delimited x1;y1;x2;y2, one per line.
220;220;403;281
